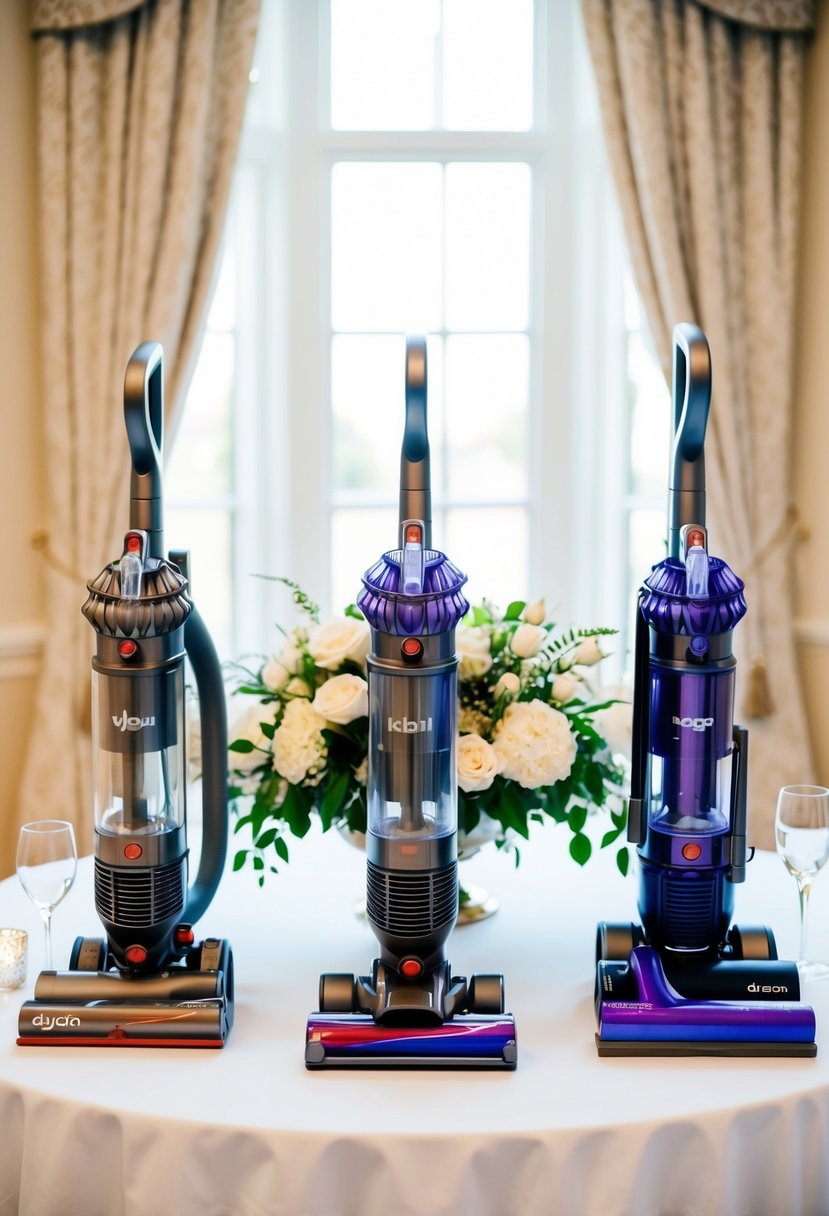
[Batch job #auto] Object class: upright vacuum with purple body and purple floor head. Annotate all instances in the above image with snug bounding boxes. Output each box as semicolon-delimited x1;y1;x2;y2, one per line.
596;325;817;1055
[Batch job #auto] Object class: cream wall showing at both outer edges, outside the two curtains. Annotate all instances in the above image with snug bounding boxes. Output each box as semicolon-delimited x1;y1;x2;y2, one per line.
0;0;829;874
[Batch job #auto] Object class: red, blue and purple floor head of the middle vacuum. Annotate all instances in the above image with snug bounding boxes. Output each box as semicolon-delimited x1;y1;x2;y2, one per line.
305;1013;518;1070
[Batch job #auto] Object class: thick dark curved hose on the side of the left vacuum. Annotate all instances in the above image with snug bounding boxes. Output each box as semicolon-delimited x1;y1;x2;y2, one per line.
179;603;229;924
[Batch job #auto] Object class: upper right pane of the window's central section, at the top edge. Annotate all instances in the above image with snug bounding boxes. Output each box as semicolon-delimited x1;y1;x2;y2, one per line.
444;0;532;131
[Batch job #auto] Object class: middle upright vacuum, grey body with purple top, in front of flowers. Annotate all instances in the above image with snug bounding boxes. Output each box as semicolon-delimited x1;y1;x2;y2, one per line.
305;338;517;1069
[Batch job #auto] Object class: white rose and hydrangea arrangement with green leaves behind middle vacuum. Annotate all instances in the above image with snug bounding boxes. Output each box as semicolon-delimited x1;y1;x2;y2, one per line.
230;584;628;883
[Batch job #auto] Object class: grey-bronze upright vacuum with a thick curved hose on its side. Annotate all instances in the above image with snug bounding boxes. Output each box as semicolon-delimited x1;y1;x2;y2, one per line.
17;342;233;1047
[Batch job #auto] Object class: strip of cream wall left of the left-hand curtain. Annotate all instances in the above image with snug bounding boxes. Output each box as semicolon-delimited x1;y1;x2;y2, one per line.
0;0;44;874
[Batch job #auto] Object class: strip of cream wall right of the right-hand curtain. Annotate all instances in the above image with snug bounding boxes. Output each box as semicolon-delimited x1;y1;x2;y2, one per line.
793;0;829;786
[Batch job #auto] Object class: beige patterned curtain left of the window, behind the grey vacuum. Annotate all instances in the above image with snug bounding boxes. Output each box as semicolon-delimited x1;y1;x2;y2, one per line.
8;0;259;865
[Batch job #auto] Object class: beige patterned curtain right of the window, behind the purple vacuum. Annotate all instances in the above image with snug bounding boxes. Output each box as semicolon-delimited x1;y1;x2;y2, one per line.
582;0;814;848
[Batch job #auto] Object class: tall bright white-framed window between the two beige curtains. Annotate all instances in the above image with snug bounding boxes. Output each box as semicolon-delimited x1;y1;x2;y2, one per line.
168;0;666;666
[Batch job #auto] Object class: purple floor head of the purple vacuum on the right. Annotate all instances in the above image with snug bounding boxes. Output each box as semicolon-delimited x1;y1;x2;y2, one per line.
596;946;817;1057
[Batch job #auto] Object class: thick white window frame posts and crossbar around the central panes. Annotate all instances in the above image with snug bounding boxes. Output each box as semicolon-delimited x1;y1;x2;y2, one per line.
192;0;628;670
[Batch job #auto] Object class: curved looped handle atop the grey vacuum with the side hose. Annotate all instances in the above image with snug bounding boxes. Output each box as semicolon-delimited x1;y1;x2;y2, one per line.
124;342;164;558
